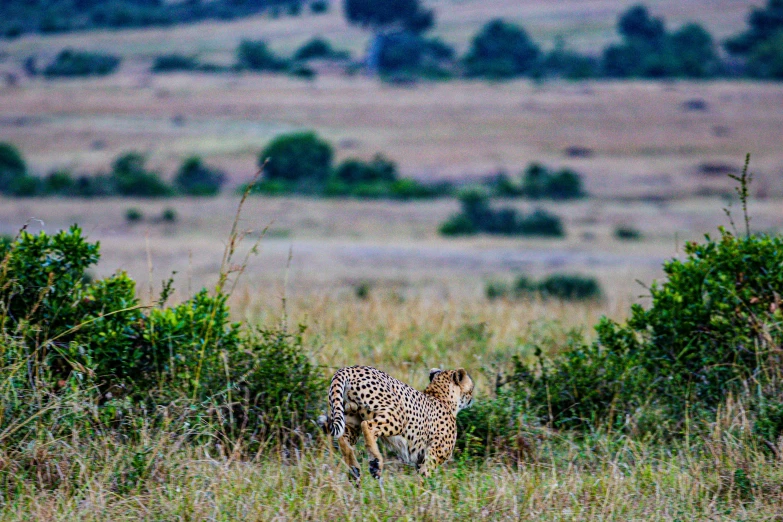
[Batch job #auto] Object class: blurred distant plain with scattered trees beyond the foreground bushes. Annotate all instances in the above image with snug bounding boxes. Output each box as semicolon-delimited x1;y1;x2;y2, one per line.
0;0;783;308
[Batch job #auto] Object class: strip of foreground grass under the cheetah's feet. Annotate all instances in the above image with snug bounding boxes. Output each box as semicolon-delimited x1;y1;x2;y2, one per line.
0;411;783;521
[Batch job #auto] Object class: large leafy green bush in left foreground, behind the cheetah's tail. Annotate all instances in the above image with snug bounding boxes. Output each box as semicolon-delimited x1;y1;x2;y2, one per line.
0;226;325;447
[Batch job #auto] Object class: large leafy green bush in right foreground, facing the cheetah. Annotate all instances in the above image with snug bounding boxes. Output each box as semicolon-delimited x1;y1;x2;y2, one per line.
516;230;783;433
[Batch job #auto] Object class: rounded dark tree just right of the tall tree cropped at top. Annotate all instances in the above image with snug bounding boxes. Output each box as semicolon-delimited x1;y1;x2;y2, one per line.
465;19;541;78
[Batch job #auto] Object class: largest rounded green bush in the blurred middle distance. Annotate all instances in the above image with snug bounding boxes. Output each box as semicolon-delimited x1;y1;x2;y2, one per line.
258;132;334;188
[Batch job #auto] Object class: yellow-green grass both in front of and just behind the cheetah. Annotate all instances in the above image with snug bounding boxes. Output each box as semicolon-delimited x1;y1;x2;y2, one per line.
0;288;783;521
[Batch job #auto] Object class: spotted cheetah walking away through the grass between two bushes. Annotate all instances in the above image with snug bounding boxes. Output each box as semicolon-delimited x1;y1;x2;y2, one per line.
319;366;473;485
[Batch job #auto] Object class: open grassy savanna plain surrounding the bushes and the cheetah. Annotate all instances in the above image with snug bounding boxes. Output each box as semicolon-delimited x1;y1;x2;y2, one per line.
0;0;783;521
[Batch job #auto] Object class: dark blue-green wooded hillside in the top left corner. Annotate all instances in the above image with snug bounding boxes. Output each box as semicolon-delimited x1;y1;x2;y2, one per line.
0;0;306;38
